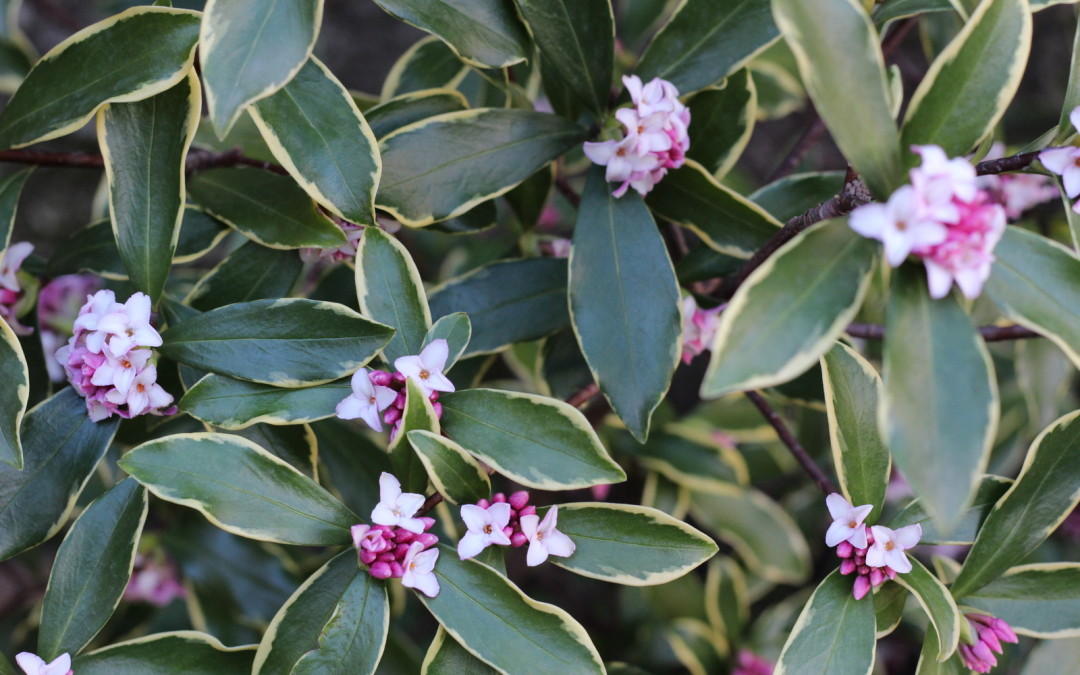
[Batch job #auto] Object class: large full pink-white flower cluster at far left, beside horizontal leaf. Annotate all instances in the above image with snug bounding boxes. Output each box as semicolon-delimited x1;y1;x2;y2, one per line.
56;291;176;421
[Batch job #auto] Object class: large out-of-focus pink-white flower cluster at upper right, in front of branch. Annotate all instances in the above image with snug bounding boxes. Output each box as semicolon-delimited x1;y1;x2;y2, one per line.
849;146;1005;298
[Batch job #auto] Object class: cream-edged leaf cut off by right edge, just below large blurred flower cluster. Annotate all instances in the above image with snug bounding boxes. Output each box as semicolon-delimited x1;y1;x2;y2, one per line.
986;227;1080;367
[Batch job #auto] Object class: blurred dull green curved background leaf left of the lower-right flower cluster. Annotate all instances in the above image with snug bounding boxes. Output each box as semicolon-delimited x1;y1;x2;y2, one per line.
690;485;812;592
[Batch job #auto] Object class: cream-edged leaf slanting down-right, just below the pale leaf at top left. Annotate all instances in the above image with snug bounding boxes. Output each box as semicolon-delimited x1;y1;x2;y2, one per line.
251;56;382;225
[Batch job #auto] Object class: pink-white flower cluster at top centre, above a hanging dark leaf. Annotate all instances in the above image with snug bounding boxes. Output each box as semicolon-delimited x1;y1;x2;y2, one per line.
584;75;690;197
